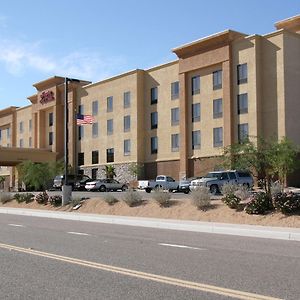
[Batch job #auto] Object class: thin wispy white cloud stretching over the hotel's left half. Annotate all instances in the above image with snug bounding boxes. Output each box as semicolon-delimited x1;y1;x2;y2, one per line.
0;39;125;81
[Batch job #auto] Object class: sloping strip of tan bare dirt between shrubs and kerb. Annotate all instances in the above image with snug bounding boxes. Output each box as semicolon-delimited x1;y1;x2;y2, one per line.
0;198;300;228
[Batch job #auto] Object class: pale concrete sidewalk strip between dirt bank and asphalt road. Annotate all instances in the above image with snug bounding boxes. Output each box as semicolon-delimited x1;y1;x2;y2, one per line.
0;207;300;241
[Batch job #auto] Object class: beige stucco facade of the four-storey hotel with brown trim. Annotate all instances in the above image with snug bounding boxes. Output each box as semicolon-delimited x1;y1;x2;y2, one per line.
0;16;300;189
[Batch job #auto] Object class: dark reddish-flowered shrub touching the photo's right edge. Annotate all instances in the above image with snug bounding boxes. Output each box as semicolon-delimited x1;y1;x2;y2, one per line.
272;193;300;214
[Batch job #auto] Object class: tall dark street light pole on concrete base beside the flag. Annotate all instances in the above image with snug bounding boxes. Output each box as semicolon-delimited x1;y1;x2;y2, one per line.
62;77;80;205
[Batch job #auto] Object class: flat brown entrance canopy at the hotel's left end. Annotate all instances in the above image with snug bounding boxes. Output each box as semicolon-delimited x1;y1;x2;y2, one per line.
0;147;56;166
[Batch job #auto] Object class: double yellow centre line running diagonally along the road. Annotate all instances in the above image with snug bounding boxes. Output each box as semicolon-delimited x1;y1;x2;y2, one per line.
0;243;281;300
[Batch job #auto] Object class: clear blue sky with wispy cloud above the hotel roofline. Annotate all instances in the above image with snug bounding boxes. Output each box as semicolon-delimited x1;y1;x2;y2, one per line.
0;0;300;110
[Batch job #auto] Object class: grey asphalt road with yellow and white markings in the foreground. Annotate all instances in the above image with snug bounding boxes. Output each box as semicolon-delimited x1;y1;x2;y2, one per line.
0;215;300;300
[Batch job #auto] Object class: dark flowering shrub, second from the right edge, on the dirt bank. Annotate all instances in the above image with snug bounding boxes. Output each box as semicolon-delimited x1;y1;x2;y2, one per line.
245;192;273;215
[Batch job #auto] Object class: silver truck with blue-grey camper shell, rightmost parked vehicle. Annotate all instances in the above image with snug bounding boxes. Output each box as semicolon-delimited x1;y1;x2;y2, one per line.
190;170;254;195
